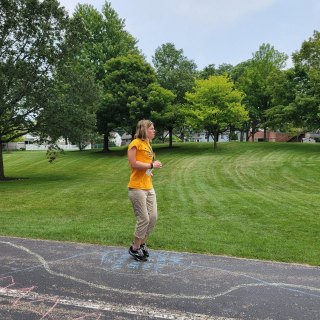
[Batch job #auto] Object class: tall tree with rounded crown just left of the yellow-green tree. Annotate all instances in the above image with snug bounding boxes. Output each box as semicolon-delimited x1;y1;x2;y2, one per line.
152;43;197;147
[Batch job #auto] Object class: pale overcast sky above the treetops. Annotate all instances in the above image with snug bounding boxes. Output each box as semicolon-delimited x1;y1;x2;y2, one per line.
60;0;320;69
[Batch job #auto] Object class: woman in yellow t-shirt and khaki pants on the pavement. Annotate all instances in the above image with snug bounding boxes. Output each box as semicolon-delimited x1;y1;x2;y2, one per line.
128;120;162;261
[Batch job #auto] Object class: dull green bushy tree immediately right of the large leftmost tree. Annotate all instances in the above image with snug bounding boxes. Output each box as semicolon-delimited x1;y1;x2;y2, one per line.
39;59;101;150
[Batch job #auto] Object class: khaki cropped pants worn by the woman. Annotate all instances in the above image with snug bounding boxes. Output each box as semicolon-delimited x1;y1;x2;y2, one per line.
129;188;158;240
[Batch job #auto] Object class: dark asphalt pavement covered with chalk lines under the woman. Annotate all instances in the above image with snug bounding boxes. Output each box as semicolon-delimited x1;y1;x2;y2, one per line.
0;237;320;320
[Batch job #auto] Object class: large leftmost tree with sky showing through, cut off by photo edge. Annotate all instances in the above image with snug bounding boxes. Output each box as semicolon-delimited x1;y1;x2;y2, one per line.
0;0;68;180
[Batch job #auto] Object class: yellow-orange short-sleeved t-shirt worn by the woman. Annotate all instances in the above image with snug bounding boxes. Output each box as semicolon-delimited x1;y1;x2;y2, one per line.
128;139;153;190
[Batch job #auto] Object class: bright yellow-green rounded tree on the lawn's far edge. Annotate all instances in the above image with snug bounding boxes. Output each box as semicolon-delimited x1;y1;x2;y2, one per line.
186;76;248;149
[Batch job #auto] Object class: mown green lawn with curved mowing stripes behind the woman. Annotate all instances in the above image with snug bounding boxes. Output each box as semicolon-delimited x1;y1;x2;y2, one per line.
0;143;320;265
